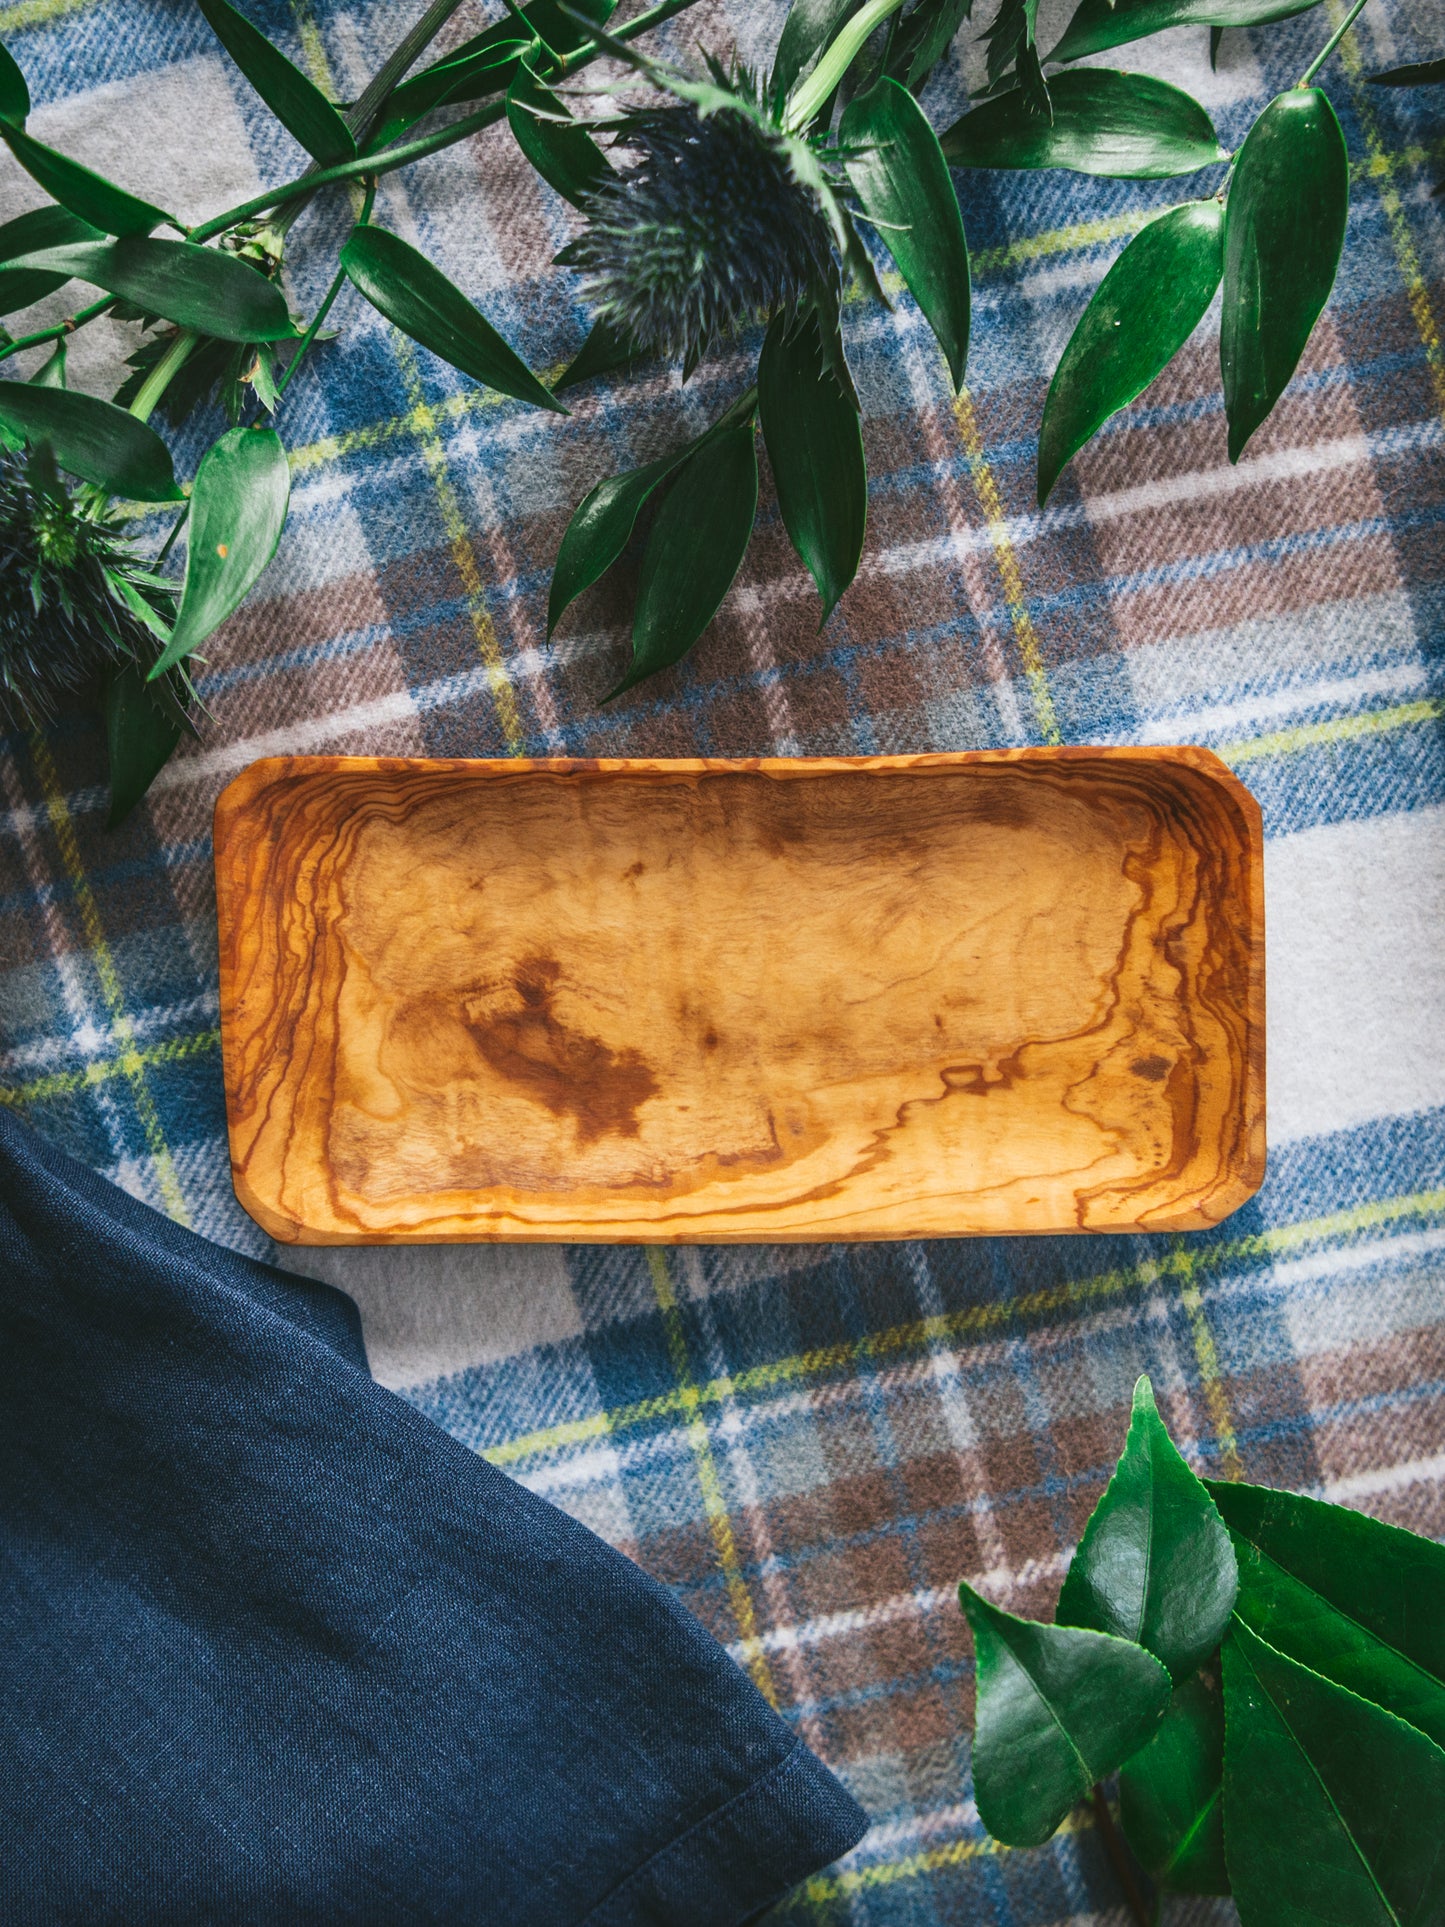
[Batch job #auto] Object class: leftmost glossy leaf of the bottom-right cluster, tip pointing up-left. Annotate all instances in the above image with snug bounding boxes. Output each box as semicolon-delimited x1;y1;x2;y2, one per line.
958;1584;1169;1846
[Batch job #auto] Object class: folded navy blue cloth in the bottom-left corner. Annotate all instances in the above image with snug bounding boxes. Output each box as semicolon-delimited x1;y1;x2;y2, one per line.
0;1110;865;1927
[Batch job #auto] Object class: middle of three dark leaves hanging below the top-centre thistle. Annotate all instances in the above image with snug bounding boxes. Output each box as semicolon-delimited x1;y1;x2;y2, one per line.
607;416;757;701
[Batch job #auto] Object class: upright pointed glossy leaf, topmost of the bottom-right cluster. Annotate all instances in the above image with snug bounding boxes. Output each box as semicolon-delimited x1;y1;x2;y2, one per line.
1058;1378;1237;1682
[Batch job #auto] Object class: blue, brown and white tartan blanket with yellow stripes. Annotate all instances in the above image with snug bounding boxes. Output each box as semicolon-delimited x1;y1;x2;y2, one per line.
0;0;1445;1927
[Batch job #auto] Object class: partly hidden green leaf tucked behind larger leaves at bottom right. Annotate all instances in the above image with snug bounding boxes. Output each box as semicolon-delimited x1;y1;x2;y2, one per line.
1119;1673;1229;1894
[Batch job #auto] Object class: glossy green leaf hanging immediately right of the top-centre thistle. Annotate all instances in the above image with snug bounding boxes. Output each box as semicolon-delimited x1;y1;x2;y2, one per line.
838;77;969;389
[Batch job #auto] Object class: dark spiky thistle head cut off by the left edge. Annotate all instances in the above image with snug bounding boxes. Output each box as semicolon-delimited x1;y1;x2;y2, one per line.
0;447;173;726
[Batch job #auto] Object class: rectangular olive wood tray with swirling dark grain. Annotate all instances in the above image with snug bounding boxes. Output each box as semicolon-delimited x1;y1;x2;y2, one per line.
216;748;1264;1245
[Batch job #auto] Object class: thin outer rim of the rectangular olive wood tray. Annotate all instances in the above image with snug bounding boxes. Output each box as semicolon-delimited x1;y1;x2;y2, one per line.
212;744;1268;1249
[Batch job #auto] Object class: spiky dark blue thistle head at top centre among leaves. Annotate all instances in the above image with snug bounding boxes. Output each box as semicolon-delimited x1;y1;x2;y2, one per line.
559;67;838;366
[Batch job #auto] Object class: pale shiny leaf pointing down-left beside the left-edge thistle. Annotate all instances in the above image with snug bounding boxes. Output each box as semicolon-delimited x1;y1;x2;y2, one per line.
148;428;291;682
